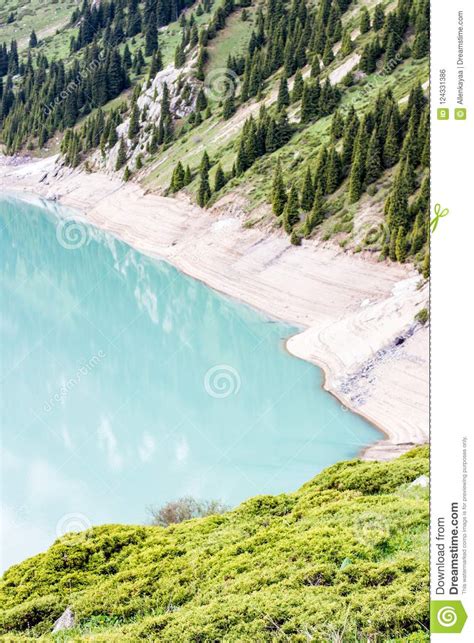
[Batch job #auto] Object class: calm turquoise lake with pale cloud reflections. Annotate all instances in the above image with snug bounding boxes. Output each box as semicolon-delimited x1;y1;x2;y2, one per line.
0;196;380;569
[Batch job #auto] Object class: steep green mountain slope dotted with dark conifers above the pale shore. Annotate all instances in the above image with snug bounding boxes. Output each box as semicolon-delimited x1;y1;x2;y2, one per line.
0;0;429;270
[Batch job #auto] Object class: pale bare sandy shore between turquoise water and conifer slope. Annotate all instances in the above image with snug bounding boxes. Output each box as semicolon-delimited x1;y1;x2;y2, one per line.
0;158;429;459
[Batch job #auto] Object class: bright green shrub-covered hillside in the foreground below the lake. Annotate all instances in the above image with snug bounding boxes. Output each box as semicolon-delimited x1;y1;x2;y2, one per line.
0;448;429;643
